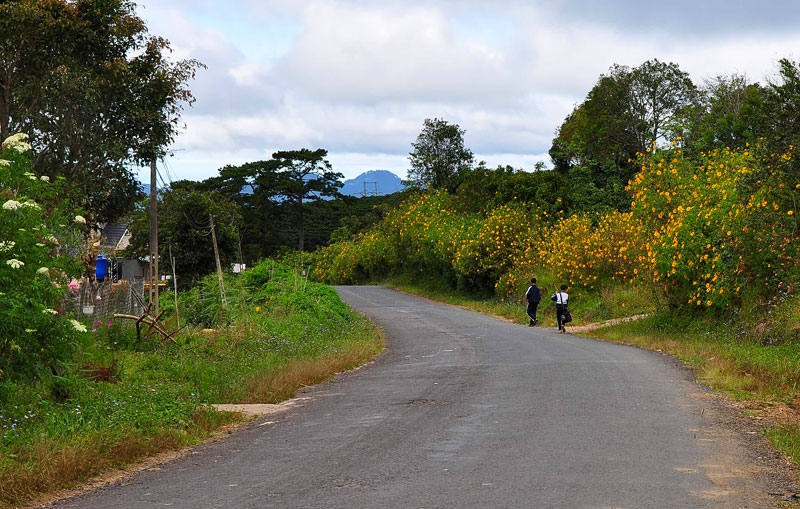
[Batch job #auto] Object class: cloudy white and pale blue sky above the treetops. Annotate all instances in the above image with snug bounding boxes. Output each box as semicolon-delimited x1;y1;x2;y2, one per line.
138;0;800;180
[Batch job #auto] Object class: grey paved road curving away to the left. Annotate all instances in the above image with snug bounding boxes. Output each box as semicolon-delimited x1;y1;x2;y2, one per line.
50;287;772;509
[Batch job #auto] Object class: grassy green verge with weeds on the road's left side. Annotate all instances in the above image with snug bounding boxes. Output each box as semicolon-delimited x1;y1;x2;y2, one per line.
0;265;384;507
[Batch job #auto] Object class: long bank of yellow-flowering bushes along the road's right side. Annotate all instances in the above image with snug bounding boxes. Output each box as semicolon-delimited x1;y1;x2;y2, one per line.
312;141;800;312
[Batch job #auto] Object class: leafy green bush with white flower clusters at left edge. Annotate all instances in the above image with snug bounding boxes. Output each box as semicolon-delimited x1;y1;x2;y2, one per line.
0;134;85;380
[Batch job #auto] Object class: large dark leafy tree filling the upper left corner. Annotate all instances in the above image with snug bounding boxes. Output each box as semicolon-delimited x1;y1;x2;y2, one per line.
0;0;201;221
